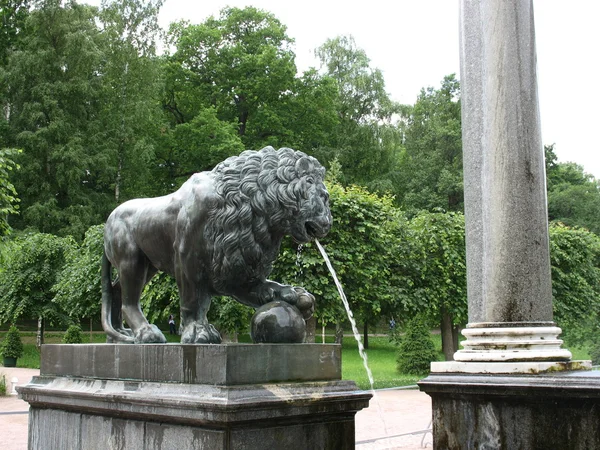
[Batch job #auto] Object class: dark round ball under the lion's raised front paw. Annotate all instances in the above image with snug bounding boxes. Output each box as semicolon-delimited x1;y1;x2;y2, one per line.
250;301;306;344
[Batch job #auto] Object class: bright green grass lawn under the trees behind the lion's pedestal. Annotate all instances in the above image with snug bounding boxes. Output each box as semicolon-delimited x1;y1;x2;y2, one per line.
0;332;589;389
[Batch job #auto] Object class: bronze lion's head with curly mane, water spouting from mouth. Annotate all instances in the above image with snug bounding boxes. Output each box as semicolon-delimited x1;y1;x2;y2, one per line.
207;147;332;288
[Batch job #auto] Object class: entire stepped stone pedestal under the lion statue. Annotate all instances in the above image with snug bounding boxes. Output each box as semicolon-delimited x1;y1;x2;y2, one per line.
19;344;371;450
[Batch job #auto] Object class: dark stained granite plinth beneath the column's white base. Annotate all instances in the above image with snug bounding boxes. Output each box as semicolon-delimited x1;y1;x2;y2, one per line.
419;371;600;450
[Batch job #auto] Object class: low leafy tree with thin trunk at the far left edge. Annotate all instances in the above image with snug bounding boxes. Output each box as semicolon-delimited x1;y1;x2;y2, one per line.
0;233;75;346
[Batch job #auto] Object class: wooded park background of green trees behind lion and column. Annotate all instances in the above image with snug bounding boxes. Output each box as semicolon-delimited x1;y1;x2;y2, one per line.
0;0;600;383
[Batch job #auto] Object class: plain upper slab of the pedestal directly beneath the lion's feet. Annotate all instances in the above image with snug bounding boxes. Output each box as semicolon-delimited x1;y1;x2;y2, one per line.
40;344;342;385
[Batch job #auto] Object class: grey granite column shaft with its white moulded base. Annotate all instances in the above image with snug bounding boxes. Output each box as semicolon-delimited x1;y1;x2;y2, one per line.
455;0;571;368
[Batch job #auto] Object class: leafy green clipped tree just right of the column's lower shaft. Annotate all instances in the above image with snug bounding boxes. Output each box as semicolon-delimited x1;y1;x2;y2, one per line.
550;224;600;344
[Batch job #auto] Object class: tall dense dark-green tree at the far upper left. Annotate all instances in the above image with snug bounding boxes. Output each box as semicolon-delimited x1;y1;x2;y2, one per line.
3;0;107;236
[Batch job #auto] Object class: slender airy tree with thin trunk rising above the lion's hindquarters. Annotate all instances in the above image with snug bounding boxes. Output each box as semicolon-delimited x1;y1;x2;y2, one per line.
95;0;165;204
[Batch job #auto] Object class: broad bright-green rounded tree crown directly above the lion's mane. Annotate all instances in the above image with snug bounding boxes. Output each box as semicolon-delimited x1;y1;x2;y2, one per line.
164;7;296;148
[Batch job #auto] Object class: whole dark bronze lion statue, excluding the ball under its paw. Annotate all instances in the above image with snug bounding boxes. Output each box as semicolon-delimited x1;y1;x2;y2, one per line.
102;147;332;344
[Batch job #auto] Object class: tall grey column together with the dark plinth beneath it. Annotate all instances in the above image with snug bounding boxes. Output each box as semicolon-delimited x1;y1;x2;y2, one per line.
419;0;600;450
